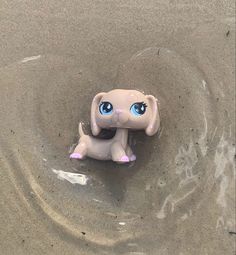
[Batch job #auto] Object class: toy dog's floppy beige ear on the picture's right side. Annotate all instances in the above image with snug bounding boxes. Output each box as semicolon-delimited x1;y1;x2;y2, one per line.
145;95;160;136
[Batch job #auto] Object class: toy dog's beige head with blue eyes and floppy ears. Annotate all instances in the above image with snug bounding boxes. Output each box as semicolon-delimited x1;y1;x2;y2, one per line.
91;89;160;136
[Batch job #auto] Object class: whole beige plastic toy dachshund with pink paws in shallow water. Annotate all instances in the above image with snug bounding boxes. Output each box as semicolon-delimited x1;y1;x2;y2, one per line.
70;89;160;163
